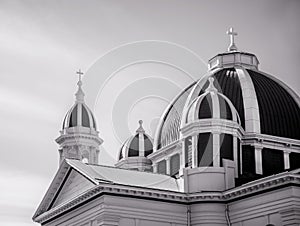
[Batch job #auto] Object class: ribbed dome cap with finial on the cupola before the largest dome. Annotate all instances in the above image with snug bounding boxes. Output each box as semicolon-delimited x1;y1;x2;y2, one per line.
184;77;240;124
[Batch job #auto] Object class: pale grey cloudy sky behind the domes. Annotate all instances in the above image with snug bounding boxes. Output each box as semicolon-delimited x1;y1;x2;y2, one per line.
0;0;300;226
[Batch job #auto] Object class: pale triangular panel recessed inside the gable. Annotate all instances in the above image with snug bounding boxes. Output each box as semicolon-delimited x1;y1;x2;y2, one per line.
50;169;95;208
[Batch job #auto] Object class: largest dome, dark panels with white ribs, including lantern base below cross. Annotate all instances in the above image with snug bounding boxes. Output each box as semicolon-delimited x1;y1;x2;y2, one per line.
154;51;300;149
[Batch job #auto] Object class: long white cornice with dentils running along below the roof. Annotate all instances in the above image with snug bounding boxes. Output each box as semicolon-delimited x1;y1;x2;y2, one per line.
33;172;300;223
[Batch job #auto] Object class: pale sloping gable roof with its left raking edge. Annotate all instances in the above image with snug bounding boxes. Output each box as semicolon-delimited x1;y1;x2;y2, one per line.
33;159;179;219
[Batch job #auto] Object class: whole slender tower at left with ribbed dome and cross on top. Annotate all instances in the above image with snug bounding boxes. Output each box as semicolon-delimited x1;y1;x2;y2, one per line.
56;70;103;164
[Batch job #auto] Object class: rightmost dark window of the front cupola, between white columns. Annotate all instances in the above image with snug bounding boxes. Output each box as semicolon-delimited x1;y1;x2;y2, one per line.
220;133;233;167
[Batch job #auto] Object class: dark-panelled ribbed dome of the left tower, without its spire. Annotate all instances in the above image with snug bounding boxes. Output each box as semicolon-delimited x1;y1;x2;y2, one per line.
63;103;97;130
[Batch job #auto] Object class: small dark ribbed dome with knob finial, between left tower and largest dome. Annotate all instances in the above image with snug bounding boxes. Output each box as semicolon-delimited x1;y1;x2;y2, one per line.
118;120;153;160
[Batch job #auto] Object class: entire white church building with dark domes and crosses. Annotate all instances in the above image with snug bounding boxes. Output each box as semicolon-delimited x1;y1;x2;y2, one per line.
33;28;300;226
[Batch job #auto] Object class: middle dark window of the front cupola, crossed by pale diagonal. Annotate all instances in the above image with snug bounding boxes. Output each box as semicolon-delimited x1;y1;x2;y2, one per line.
198;133;213;166
